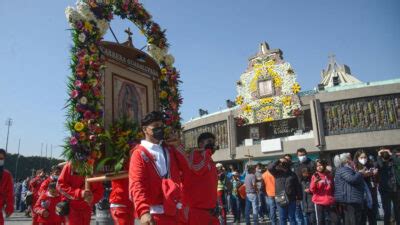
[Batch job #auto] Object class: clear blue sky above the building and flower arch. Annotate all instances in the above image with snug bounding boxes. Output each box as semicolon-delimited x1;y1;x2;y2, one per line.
0;0;400;157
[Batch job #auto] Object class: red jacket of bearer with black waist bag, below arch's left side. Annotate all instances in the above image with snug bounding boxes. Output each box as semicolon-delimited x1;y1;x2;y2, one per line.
57;162;104;210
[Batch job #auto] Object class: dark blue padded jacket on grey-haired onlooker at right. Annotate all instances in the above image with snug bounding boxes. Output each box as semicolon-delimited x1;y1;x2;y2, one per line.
334;166;364;204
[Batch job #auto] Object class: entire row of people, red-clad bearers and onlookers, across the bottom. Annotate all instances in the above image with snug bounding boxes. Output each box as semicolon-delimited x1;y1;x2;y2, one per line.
0;112;400;225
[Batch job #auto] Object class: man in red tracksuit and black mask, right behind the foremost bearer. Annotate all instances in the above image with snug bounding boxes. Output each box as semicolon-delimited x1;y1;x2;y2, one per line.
183;132;219;225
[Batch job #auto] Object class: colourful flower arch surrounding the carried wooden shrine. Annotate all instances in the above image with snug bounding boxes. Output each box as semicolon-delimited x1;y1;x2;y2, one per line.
63;0;182;175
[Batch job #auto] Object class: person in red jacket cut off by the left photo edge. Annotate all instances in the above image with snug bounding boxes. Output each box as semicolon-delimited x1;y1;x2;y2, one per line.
0;149;14;225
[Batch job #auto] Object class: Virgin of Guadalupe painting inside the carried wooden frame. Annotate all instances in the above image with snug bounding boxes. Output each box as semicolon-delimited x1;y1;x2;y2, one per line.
113;75;147;122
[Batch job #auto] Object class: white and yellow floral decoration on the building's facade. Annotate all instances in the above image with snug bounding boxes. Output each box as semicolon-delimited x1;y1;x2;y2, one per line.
235;59;302;126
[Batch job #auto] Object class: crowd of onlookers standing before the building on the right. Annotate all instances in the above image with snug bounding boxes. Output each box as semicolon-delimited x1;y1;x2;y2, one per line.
216;148;400;225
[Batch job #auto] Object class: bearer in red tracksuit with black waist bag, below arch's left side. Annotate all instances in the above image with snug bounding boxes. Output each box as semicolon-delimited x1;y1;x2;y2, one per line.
57;162;104;225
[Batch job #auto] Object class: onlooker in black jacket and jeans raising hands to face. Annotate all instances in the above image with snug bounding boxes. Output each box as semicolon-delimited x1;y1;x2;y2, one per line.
268;154;303;225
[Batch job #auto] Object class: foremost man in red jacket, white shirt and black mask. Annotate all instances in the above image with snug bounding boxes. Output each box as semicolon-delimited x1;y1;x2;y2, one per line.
129;112;186;225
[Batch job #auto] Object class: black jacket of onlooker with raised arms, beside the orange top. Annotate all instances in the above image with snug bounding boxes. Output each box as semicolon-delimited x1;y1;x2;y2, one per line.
268;160;303;201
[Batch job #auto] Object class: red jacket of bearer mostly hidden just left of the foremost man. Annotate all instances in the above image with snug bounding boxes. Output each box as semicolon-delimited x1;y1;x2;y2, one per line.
110;150;133;207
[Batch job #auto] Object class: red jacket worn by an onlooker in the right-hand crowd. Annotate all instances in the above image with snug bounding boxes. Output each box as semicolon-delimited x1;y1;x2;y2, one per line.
310;172;335;206
